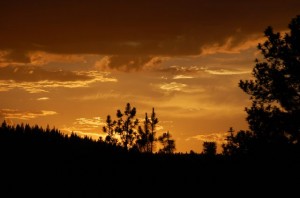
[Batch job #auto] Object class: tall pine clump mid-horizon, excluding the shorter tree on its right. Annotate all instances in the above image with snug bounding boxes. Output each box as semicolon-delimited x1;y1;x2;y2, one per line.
99;103;162;153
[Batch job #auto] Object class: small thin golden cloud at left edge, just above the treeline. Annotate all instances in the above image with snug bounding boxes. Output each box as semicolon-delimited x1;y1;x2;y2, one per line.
0;109;57;120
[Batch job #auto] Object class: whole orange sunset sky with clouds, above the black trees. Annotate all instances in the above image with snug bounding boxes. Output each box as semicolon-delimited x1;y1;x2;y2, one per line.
0;0;300;152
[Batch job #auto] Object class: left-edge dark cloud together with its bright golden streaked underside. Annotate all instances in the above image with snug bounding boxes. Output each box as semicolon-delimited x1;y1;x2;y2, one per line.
0;66;117;93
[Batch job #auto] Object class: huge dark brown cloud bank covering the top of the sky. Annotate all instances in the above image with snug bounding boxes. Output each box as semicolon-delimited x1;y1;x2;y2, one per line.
0;0;300;62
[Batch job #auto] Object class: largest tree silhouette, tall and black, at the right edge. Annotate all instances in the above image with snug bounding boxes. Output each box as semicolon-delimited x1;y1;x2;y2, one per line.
223;15;300;154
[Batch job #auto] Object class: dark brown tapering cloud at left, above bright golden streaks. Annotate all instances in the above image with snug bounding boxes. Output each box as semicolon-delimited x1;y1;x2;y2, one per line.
0;66;93;82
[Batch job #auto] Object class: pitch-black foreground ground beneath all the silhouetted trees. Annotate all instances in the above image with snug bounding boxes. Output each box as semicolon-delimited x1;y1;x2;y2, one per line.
0;128;300;198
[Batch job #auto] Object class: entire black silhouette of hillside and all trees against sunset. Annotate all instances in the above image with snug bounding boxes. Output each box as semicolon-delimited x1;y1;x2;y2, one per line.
0;16;300;198
